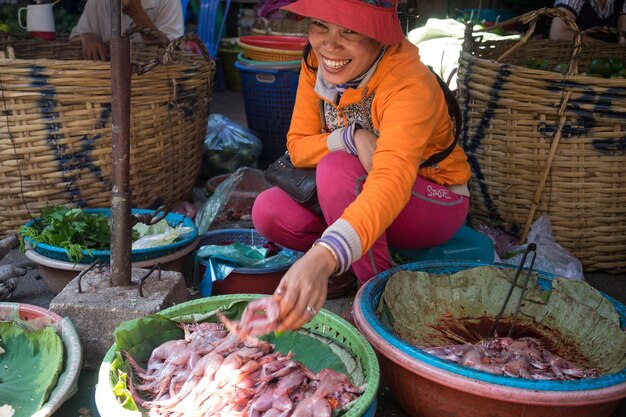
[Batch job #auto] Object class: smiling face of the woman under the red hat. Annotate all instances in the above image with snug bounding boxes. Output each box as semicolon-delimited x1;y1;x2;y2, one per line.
309;19;381;85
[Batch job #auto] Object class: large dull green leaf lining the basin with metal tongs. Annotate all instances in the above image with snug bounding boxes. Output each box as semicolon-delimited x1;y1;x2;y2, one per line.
378;266;626;374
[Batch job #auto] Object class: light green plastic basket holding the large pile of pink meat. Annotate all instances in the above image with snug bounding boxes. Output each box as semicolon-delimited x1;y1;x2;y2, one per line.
96;294;380;417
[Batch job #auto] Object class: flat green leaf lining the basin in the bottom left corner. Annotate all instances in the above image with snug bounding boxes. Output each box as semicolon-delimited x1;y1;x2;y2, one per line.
0;321;63;417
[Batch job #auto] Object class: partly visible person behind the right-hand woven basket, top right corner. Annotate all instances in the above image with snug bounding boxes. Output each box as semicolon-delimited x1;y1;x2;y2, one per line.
550;0;626;43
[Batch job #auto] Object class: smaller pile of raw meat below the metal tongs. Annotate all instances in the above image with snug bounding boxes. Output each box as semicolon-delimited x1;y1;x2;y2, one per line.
423;337;599;380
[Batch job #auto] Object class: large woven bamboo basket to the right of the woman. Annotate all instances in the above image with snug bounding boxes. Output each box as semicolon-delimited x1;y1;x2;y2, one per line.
458;8;626;273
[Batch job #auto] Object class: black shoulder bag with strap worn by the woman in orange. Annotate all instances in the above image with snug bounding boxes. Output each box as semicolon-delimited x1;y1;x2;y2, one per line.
265;67;461;215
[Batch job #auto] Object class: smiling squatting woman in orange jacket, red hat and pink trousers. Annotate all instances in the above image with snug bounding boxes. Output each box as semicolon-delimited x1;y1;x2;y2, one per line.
252;0;471;331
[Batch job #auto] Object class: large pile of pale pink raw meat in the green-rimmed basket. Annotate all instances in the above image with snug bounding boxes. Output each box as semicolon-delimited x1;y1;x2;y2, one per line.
126;297;365;417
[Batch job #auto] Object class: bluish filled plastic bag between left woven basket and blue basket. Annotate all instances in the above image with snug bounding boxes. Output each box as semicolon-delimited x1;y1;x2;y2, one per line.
202;114;263;178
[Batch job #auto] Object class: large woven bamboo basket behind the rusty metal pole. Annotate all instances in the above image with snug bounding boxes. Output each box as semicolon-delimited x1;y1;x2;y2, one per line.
0;37;215;235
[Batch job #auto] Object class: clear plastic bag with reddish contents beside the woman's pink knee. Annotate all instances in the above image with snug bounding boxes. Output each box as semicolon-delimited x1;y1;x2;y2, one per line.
195;167;272;234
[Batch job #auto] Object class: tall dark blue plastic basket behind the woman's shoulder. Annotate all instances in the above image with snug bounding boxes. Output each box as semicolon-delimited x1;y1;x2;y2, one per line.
235;62;300;162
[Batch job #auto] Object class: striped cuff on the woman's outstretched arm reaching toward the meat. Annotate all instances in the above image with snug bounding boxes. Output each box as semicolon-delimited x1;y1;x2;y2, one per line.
316;219;361;275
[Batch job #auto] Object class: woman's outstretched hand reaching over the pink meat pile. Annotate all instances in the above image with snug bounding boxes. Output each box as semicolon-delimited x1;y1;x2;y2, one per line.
274;246;337;332
